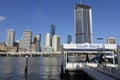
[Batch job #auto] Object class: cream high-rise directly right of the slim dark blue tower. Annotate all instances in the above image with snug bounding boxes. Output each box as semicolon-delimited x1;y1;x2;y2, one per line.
52;35;60;52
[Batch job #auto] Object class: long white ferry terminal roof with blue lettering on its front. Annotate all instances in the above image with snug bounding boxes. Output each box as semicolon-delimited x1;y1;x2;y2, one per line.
63;43;117;53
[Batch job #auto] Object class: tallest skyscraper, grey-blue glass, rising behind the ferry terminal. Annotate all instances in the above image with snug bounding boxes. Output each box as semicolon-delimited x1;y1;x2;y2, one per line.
74;4;93;43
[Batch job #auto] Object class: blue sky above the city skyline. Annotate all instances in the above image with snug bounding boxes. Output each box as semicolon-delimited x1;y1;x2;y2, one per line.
0;0;120;45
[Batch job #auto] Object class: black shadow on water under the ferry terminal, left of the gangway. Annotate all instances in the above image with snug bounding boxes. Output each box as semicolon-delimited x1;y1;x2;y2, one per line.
60;59;94;80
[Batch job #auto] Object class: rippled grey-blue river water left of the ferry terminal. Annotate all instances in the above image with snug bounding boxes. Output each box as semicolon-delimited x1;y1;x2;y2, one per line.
0;57;61;80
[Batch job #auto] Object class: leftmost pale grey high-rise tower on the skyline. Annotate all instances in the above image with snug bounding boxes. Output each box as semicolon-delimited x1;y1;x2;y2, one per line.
6;29;15;47
